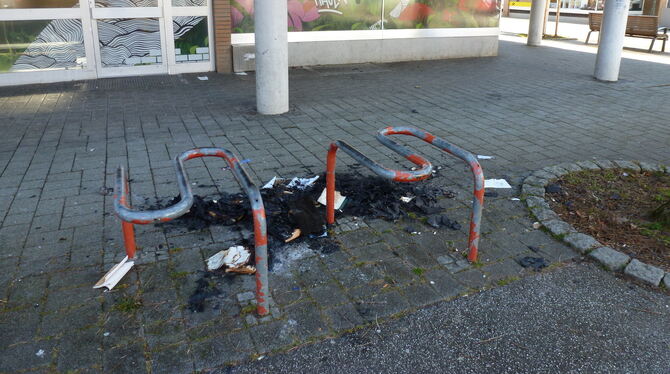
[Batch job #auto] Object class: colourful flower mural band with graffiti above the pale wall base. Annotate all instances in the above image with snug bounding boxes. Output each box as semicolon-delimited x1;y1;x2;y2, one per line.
232;0;498;33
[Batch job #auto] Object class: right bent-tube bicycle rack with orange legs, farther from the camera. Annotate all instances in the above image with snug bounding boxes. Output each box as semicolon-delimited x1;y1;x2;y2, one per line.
326;127;484;262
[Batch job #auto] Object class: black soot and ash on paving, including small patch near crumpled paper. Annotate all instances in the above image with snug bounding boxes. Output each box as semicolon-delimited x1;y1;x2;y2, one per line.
150;174;460;312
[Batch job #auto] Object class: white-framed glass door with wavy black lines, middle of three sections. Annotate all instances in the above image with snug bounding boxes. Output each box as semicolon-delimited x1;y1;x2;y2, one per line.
89;0;171;78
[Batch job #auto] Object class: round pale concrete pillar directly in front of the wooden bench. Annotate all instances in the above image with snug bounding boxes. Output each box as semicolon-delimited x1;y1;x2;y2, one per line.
594;0;630;82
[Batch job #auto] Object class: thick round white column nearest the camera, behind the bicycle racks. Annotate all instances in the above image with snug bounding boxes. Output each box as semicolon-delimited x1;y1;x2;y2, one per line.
254;0;288;114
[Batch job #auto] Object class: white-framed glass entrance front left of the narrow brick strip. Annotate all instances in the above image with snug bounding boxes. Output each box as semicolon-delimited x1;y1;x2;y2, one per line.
0;0;214;85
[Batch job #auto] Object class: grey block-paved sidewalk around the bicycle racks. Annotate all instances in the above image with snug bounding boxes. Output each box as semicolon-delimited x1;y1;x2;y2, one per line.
0;36;670;373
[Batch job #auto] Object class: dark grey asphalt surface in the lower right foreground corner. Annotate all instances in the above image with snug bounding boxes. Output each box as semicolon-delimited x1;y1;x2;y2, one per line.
232;264;670;373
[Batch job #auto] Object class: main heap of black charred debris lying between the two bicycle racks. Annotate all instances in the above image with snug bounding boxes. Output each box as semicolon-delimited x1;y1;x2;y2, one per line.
151;173;460;242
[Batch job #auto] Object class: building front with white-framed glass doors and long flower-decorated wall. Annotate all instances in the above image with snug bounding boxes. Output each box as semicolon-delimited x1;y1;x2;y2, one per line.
0;0;499;85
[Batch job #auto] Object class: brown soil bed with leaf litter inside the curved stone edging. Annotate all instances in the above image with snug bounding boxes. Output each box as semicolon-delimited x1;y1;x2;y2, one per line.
545;169;670;271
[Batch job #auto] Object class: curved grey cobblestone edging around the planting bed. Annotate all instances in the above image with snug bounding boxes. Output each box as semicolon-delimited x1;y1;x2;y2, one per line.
521;160;670;289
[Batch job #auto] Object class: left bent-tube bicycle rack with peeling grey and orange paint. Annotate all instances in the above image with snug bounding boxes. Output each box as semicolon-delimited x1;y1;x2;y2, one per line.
98;148;269;315
